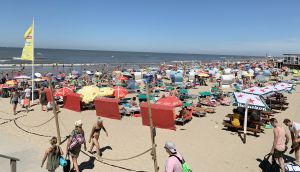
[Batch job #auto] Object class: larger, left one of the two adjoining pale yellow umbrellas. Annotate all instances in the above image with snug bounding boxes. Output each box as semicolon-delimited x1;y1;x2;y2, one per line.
77;85;101;103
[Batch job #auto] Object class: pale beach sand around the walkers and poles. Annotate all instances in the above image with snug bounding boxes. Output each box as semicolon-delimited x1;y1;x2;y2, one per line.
0;86;300;172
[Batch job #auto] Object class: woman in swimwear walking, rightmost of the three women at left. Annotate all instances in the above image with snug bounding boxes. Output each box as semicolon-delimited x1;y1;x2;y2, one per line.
89;117;108;160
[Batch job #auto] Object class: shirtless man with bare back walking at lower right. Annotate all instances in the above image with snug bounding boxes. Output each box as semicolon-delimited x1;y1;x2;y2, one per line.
270;118;289;172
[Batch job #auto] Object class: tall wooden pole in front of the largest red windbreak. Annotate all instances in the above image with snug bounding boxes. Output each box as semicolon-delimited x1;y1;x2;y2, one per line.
146;83;158;172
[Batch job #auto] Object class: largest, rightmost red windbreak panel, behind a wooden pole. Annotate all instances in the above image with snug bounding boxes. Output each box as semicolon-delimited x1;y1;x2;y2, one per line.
141;102;176;130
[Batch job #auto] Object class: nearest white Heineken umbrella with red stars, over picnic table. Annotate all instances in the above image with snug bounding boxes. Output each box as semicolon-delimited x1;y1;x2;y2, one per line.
232;92;271;111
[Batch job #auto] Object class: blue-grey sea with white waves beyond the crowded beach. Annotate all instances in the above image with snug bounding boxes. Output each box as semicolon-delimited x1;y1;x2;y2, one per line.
0;47;261;72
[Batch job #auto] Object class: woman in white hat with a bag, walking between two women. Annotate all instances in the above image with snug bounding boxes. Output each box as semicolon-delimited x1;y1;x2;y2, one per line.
66;120;87;172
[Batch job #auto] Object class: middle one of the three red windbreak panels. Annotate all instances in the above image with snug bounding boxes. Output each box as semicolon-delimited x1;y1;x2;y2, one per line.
95;98;121;120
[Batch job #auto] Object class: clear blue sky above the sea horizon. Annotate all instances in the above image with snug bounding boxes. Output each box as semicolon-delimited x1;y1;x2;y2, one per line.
0;0;300;55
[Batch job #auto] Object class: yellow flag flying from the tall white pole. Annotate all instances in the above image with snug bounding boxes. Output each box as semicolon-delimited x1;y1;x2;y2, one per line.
21;21;34;61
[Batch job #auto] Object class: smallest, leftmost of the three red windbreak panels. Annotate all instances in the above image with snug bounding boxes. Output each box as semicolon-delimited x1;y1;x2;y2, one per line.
64;93;81;112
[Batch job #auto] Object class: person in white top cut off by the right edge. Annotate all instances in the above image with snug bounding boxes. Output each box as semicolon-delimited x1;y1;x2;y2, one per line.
283;119;300;165
